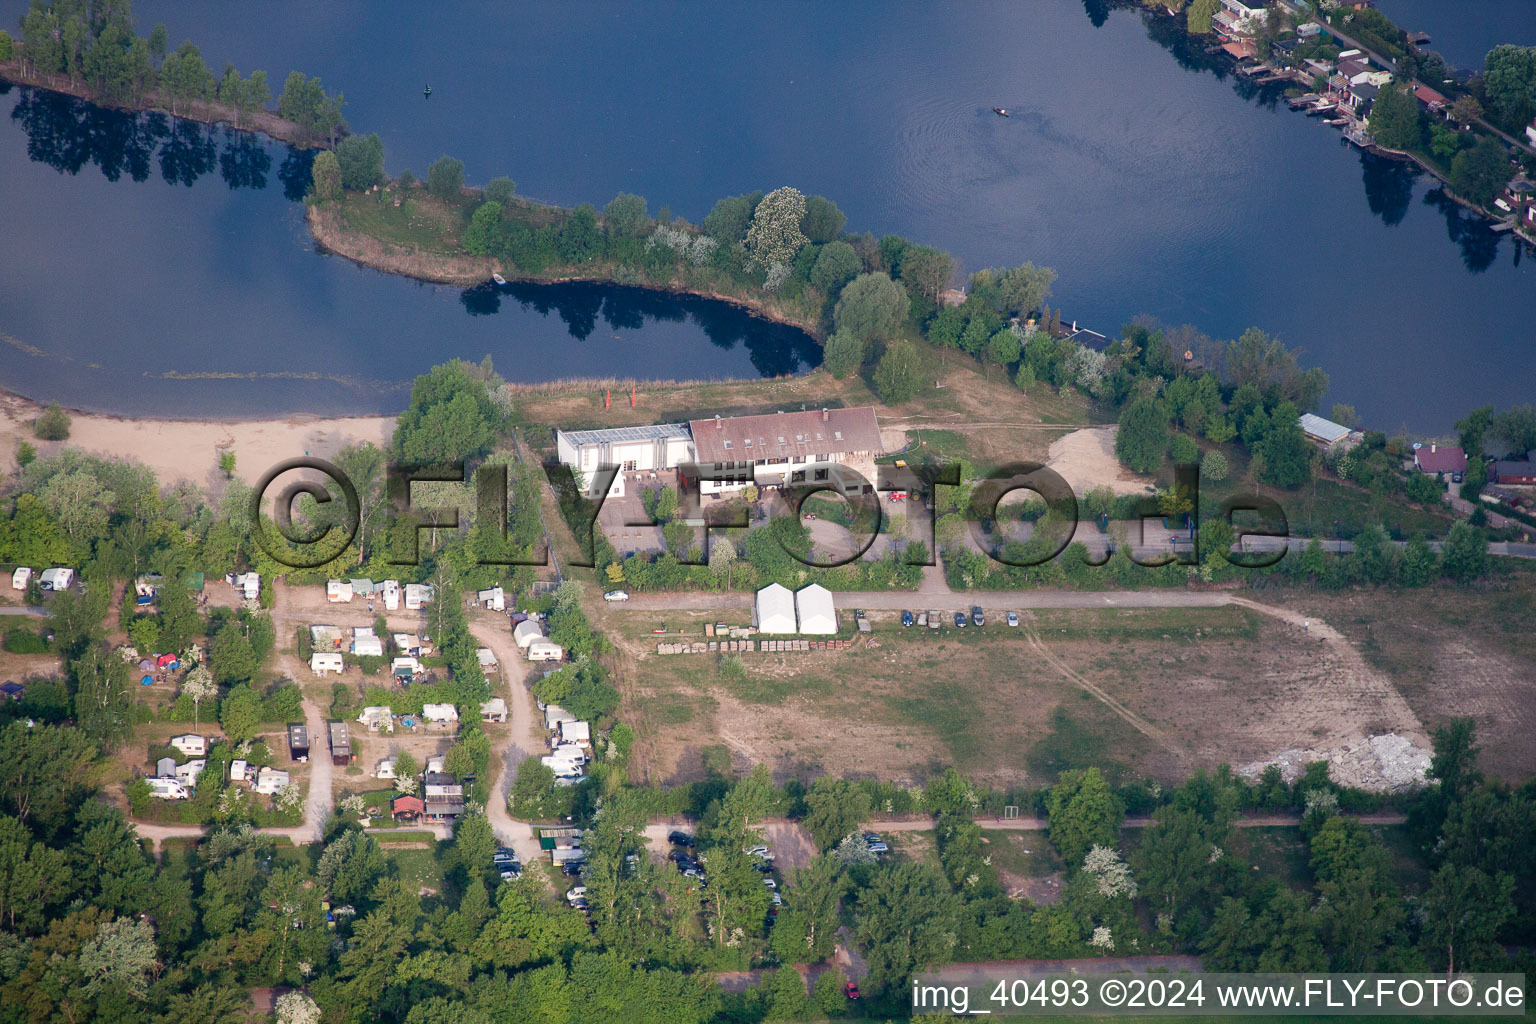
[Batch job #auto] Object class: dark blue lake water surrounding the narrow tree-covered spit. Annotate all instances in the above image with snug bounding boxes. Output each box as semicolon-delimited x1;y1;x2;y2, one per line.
0;0;1536;430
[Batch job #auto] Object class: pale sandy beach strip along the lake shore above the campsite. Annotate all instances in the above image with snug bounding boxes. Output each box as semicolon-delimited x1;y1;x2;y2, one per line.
0;395;395;491
